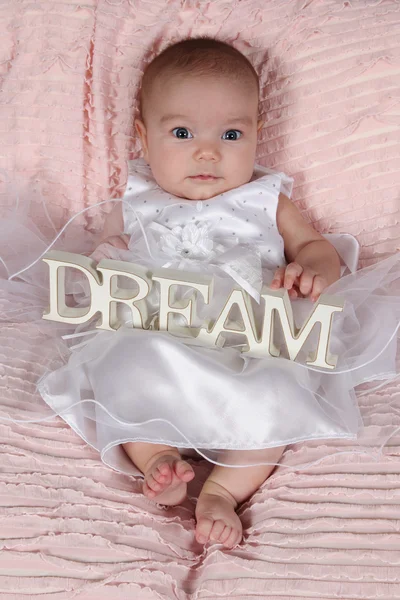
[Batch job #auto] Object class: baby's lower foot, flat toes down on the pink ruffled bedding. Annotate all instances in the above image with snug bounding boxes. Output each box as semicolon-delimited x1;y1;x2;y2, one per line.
196;481;242;548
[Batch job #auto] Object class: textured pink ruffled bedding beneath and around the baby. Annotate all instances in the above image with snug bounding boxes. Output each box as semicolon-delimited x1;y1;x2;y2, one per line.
0;0;400;600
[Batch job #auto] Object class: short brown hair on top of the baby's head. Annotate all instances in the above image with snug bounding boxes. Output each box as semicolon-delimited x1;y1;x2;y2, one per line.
139;37;260;119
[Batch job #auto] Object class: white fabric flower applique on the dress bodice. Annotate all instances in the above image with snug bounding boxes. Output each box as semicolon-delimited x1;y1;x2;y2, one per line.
159;222;216;262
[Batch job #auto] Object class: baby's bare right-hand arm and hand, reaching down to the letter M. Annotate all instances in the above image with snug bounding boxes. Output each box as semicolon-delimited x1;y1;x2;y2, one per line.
271;194;340;301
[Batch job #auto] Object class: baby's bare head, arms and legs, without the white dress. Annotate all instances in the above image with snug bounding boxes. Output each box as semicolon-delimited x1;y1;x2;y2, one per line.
98;38;340;548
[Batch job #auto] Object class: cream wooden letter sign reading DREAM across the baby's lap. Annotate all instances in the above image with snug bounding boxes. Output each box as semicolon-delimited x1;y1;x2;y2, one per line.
43;251;344;369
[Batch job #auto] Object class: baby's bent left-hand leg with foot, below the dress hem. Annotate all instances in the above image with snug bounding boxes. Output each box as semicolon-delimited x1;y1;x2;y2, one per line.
123;442;194;505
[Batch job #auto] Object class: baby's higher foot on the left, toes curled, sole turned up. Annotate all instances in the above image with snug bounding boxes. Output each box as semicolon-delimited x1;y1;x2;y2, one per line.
143;454;194;506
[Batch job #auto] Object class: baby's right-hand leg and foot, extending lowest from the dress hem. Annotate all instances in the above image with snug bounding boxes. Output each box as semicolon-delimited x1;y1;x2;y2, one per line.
196;446;285;548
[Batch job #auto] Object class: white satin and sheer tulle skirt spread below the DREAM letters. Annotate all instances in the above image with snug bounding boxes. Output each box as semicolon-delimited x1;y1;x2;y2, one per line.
0;198;400;475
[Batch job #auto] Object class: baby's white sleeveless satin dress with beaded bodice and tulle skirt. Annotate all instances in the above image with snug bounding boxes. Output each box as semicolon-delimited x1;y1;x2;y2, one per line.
0;159;400;474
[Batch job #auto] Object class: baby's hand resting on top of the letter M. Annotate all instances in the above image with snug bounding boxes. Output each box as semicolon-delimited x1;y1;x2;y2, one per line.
270;262;328;302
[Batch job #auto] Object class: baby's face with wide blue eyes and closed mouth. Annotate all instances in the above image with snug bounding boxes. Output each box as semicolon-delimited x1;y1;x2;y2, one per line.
135;75;262;200
